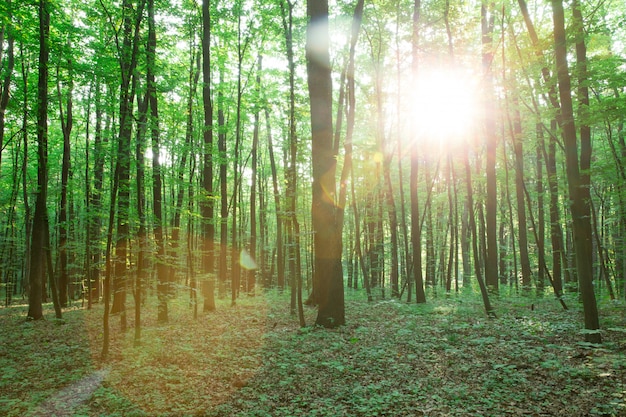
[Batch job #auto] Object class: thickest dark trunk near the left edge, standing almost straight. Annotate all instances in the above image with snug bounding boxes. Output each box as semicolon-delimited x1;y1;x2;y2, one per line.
28;0;50;320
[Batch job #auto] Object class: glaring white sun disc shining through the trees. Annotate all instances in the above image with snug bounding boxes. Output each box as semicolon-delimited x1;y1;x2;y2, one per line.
410;69;479;150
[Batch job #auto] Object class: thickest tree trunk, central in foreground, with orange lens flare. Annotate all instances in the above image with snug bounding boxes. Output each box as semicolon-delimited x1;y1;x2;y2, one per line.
306;0;345;328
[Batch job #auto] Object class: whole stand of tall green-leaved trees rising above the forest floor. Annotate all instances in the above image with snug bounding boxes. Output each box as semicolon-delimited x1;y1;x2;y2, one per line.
0;0;626;342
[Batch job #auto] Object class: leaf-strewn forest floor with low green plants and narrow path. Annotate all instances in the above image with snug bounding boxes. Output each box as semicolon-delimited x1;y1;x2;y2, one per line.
0;292;626;417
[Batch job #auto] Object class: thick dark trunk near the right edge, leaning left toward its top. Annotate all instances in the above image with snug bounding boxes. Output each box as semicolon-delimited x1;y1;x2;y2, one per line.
552;0;602;343
